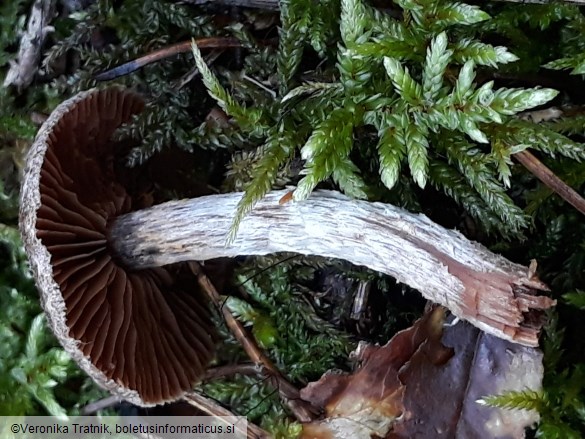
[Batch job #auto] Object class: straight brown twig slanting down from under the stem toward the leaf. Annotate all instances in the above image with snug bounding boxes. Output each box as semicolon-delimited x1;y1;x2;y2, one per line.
189;262;317;422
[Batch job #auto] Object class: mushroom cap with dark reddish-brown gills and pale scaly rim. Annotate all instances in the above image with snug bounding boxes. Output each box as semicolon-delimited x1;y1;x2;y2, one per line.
20;88;215;406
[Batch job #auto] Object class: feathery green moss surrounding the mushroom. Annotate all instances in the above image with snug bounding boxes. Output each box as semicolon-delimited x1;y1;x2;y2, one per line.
0;0;585;437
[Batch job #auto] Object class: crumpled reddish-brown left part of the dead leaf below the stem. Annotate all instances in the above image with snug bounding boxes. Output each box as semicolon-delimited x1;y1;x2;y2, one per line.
301;307;450;439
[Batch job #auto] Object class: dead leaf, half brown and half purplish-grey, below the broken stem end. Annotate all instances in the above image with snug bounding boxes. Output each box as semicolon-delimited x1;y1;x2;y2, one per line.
301;307;543;439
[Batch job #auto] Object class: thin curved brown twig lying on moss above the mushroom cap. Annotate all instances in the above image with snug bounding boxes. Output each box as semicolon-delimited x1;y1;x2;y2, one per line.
95;37;242;81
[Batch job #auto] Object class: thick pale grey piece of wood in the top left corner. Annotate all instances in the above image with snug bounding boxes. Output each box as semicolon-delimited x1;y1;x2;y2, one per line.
4;0;54;90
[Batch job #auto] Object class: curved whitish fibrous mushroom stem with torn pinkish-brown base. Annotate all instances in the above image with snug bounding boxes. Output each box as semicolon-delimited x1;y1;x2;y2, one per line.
109;191;554;346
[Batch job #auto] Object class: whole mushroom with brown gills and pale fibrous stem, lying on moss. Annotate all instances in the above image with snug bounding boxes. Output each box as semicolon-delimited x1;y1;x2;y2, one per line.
21;89;555;405
